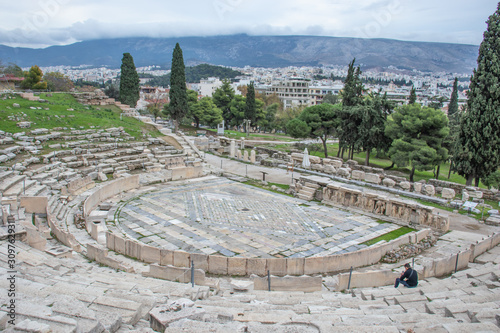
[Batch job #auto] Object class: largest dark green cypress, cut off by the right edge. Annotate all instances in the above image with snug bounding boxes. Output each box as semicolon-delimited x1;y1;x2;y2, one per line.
454;3;500;186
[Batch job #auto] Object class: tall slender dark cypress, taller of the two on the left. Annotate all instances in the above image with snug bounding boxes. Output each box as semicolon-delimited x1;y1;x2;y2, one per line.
166;43;188;132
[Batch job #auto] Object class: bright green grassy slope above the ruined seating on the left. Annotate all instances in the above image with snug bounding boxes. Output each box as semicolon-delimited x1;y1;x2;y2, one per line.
0;93;161;143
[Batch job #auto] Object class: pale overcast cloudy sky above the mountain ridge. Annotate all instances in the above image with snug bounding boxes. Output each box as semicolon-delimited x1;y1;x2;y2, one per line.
0;0;498;48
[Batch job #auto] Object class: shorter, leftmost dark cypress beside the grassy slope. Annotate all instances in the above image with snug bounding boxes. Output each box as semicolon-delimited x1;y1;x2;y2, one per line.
120;53;140;108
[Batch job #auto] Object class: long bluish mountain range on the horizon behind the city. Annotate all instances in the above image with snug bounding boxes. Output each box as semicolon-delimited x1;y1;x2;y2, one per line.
0;35;479;74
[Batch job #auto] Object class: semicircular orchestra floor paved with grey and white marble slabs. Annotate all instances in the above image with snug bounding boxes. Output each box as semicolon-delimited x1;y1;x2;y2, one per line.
115;177;399;258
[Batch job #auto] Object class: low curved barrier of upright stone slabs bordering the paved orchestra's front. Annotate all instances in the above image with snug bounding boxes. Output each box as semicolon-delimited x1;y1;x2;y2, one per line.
106;229;430;276
